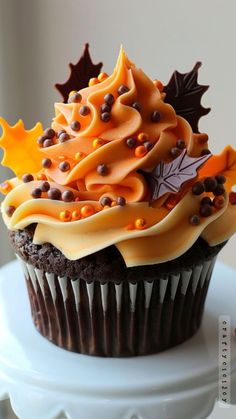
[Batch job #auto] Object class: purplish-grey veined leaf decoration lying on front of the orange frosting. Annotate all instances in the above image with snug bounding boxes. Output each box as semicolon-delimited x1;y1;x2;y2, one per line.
139;149;211;202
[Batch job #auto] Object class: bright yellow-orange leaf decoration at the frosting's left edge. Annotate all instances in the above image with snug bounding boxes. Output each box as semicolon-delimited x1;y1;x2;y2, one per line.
0;118;43;176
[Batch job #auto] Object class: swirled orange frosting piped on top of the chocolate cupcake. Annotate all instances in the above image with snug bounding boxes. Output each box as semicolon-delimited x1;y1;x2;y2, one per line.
0;49;236;266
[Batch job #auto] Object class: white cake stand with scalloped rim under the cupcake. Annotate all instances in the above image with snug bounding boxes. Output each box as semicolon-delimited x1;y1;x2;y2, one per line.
0;262;236;419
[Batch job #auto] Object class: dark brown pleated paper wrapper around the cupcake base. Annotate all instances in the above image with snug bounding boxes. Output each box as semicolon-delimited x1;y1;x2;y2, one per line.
15;257;216;356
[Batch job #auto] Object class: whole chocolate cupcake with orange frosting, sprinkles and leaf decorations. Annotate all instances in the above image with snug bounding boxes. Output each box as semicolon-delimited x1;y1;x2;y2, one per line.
0;45;236;357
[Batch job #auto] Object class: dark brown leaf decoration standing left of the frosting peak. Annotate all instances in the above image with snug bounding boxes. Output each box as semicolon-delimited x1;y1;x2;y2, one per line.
55;44;102;103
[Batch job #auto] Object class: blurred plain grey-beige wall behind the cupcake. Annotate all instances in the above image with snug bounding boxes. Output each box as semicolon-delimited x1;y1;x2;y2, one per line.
0;0;236;267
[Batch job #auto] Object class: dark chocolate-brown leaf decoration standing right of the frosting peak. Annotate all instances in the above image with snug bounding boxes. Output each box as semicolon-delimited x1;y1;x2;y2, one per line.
164;62;211;132
